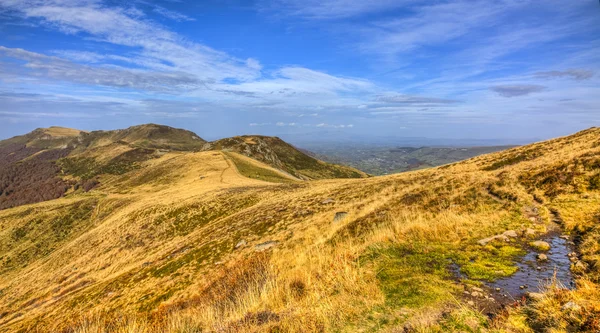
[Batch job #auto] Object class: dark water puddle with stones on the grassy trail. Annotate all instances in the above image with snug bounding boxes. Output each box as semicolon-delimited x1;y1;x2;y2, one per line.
488;232;575;301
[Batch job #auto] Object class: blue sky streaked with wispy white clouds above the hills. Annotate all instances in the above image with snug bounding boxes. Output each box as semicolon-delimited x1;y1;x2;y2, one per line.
0;0;600;143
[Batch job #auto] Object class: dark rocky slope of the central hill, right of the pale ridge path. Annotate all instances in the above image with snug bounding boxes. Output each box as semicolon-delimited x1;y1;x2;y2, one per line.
210;135;367;179
